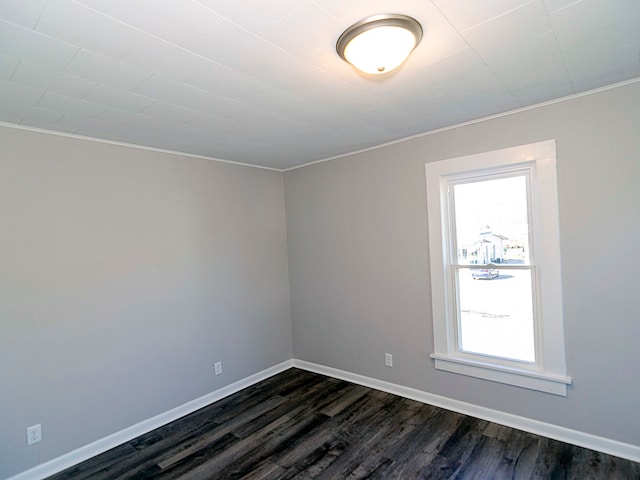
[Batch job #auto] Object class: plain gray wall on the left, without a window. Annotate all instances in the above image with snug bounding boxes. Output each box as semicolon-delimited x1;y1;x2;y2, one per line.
0;127;292;478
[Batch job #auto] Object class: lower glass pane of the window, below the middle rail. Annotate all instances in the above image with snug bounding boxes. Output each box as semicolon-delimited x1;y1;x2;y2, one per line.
458;268;535;362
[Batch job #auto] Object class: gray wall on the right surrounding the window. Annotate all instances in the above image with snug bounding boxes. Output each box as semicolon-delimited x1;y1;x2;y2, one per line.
285;83;640;446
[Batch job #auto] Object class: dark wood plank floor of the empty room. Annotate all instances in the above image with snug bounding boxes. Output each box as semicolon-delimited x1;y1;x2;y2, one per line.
50;369;640;480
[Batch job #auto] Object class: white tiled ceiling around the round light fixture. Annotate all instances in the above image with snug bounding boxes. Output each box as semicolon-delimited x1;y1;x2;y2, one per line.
0;0;640;169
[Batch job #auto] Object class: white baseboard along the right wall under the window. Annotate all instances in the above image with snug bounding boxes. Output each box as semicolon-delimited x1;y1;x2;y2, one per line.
293;359;640;462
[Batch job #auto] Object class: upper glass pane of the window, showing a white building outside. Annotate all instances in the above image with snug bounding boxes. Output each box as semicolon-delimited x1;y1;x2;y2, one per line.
454;175;530;265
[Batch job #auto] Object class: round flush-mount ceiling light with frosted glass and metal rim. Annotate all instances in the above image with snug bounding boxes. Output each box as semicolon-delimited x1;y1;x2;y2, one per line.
336;14;422;75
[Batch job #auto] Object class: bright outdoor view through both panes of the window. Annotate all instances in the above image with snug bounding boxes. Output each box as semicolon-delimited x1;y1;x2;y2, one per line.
452;175;535;362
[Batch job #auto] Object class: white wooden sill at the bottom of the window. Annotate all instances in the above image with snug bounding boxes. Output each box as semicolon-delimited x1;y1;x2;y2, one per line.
429;353;572;397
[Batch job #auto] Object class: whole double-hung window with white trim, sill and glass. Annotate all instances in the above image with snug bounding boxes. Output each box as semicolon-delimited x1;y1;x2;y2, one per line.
426;140;571;396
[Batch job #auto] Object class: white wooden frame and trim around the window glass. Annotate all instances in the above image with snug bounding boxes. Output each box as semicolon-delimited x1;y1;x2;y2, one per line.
425;140;572;396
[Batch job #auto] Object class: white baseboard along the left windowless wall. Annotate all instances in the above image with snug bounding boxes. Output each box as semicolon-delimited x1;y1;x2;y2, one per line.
7;360;293;480
